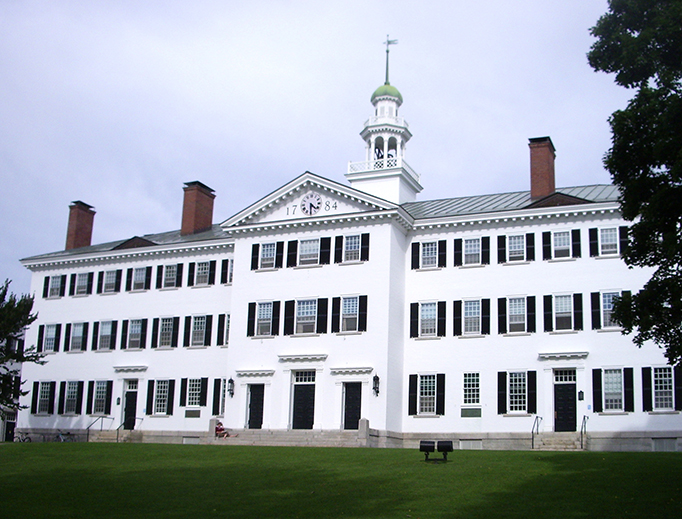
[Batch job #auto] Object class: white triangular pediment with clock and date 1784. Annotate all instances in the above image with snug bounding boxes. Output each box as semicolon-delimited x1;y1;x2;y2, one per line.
221;172;398;229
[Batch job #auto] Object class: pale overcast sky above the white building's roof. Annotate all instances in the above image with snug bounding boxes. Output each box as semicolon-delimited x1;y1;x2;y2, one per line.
0;0;630;293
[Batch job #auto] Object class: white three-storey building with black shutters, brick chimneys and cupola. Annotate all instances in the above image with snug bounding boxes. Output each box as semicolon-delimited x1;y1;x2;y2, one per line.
18;76;682;450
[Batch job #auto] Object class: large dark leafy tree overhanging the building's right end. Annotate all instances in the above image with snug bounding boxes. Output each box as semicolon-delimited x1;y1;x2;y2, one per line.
587;0;682;365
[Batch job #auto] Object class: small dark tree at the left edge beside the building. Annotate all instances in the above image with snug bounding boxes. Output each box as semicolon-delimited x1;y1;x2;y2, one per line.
0;280;45;414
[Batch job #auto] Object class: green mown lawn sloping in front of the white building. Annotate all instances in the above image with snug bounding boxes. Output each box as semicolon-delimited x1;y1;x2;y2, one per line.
0;443;682;519
